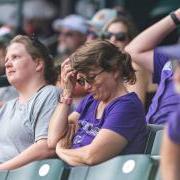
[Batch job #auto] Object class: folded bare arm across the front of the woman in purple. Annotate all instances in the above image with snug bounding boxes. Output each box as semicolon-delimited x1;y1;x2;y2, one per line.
56;129;128;166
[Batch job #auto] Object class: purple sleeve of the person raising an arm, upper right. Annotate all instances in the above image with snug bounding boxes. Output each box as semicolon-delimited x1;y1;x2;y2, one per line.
153;48;169;84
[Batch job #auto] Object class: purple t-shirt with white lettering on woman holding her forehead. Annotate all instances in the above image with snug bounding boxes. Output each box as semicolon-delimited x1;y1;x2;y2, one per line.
72;93;147;154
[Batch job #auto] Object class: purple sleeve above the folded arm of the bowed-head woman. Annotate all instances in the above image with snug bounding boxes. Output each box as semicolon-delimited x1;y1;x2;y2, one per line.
102;98;145;142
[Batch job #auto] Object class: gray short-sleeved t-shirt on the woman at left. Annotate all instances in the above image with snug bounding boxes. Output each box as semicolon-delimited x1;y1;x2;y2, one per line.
0;85;60;163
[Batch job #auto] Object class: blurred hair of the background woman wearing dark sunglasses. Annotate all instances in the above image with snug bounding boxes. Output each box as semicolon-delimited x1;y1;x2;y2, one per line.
103;16;138;40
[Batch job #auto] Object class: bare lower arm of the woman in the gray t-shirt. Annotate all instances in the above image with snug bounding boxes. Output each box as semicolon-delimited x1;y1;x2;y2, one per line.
0;139;55;170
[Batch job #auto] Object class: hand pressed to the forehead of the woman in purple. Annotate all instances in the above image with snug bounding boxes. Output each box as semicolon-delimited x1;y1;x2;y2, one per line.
61;58;77;97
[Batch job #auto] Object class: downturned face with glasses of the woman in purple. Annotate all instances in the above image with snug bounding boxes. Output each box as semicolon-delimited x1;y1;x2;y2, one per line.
77;69;117;101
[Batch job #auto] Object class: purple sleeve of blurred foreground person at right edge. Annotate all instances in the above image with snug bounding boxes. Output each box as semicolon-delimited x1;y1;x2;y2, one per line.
168;106;180;144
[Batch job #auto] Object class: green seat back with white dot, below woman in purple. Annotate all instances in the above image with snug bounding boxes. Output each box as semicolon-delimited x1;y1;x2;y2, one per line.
68;154;156;180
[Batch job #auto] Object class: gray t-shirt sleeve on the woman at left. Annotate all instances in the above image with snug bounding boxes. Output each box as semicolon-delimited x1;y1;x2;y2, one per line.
33;87;60;141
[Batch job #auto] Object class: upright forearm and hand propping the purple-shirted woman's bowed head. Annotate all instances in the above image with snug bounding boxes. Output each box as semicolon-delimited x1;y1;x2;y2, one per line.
48;59;79;149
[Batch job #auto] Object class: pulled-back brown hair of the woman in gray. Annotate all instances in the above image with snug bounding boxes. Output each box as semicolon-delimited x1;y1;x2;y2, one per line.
10;35;57;84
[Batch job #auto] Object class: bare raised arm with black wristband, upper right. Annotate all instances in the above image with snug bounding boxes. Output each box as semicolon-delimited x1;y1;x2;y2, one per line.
125;9;180;73
